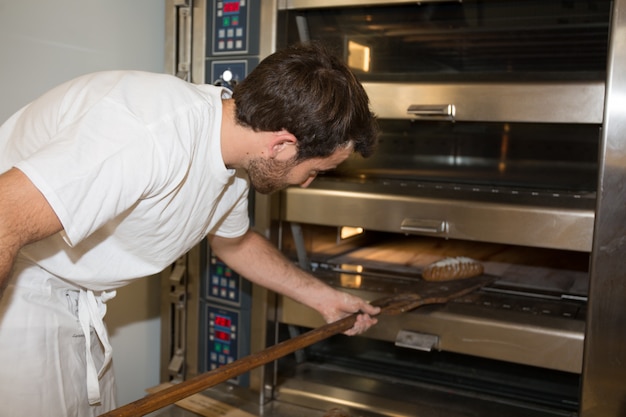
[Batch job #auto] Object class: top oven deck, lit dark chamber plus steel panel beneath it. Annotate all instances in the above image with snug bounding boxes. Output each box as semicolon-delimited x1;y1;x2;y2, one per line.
277;0;611;123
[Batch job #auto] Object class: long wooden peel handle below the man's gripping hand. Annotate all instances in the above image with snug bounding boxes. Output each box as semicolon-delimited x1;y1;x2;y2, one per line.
100;314;357;417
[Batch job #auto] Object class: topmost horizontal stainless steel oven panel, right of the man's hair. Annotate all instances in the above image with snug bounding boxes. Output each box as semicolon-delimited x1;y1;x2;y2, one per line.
363;82;604;124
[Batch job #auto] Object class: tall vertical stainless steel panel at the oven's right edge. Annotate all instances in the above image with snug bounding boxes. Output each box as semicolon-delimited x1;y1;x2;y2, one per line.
580;0;626;417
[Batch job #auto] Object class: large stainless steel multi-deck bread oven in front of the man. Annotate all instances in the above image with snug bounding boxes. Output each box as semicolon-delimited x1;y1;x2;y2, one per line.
157;0;626;417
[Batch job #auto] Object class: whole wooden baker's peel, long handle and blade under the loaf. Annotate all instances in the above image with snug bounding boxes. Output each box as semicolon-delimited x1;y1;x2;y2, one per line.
100;275;495;417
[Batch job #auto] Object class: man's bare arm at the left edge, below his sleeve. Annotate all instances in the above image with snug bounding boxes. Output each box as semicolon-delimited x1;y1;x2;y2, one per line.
0;168;63;297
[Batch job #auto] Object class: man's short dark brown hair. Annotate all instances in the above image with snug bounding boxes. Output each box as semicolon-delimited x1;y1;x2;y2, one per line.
233;43;378;161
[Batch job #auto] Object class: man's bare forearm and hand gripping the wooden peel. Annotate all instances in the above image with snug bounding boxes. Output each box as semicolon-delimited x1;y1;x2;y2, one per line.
209;231;380;335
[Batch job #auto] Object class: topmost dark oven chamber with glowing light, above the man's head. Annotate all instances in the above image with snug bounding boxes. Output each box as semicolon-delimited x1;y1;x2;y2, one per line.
277;0;611;82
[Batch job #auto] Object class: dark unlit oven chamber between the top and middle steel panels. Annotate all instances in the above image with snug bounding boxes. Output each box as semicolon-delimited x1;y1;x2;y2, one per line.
330;119;600;194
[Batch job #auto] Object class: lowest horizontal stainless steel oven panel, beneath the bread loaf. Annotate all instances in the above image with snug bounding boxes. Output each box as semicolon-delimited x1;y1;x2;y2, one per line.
280;292;585;373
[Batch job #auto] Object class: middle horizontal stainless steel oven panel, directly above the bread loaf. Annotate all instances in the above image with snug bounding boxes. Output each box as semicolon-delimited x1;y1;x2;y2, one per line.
282;187;594;251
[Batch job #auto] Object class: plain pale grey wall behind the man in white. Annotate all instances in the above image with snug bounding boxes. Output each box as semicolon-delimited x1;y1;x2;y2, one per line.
0;0;165;405
